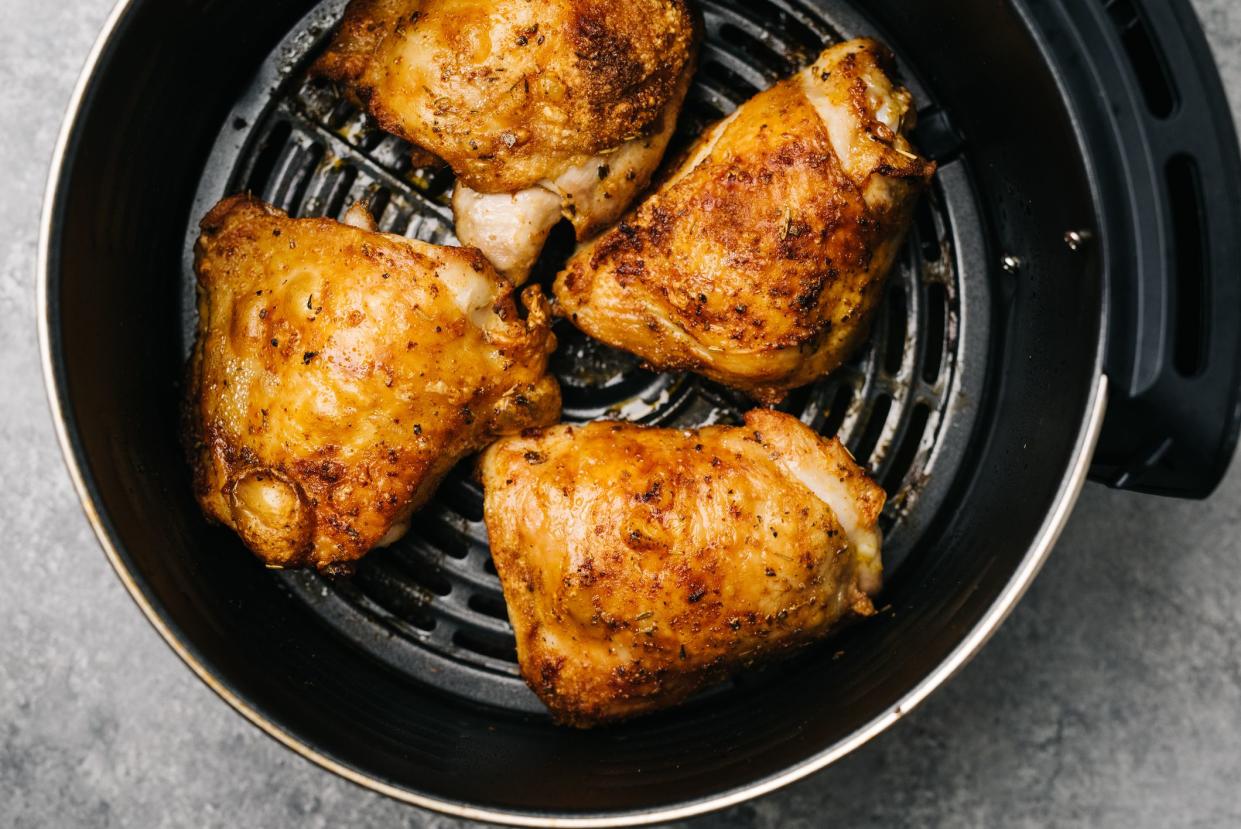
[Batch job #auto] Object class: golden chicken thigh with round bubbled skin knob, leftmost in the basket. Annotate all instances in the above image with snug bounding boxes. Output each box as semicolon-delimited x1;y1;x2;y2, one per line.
185;196;560;568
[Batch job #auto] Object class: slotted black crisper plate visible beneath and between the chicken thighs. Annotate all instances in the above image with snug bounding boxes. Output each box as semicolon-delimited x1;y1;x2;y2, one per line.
182;0;990;712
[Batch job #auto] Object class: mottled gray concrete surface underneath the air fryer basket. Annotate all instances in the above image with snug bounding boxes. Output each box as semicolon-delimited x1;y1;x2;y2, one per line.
7;0;1241;828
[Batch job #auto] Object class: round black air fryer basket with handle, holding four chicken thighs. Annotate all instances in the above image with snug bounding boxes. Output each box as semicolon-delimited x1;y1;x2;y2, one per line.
43;0;1241;824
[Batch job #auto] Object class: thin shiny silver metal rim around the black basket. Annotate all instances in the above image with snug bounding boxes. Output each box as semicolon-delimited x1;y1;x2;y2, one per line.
36;0;1108;827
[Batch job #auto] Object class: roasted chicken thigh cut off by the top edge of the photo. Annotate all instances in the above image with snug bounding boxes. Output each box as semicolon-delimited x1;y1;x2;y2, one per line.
313;0;699;284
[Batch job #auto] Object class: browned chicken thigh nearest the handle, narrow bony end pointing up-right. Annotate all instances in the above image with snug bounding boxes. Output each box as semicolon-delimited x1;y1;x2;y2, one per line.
555;40;934;403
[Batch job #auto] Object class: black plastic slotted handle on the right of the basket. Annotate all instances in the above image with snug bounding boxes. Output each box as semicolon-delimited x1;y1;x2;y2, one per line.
1087;1;1241;498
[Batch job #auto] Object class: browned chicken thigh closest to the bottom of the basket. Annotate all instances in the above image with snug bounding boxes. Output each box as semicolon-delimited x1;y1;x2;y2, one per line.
480;410;885;727
